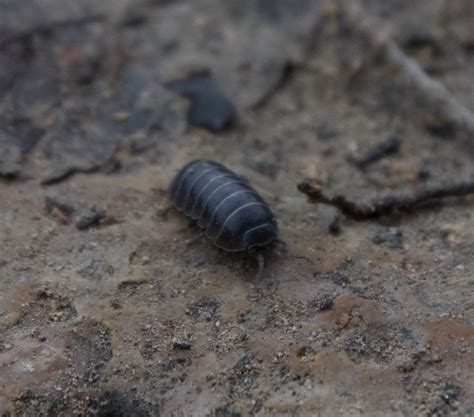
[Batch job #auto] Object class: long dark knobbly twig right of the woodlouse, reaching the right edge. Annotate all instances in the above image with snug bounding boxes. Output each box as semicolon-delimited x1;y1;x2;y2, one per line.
298;180;474;220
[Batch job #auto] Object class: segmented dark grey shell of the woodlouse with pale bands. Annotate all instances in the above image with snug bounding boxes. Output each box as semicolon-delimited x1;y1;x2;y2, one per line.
169;160;278;252
